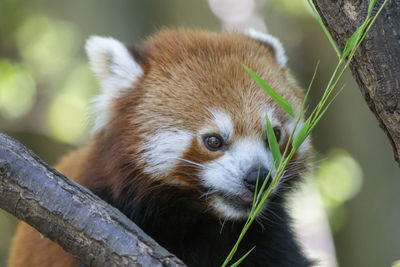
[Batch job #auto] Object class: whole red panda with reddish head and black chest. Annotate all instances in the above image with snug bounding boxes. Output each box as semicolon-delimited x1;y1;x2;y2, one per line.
9;30;311;267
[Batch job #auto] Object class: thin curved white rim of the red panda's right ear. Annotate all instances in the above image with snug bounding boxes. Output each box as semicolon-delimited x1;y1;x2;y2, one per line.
245;29;287;68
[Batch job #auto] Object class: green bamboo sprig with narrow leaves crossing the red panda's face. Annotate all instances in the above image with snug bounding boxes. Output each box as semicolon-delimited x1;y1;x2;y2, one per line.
222;0;388;267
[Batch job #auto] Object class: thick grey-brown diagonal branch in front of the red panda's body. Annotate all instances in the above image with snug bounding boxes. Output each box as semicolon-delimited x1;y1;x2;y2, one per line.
0;133;185;266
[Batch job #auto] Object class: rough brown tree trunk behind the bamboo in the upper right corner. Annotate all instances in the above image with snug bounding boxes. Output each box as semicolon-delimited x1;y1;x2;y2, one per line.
313;0;400;165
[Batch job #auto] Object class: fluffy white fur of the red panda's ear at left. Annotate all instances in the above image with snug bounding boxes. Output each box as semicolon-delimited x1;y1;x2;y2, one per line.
85;36;143;132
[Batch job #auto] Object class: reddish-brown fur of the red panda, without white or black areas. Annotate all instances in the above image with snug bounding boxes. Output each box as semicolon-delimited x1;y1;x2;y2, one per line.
9;30;310;267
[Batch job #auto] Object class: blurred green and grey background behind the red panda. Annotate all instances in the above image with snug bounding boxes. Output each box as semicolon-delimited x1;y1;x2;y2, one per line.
0;0;400;267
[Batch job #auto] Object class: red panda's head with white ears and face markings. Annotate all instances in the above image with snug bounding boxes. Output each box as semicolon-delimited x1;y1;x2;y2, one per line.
86;30;309;220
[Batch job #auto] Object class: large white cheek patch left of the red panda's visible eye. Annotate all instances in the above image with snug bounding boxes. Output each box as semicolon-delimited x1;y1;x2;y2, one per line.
143;129;192;178
